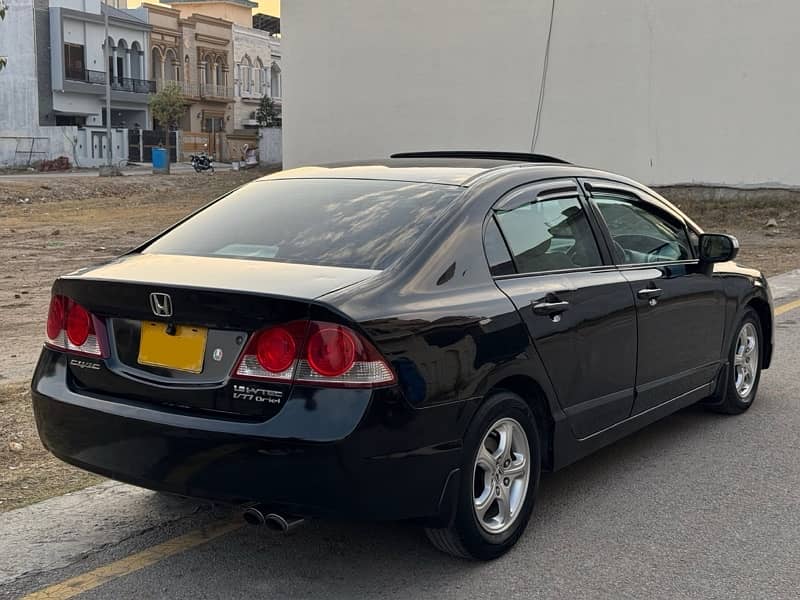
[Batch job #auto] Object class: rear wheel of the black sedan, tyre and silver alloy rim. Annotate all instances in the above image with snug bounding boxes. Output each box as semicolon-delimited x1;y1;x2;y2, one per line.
425;391;541;560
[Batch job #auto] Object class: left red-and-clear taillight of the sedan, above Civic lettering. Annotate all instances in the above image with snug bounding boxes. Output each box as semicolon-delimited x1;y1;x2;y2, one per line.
46;296;103;356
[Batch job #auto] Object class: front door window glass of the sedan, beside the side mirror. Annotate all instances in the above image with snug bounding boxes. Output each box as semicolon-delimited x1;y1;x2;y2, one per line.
592;195;692;264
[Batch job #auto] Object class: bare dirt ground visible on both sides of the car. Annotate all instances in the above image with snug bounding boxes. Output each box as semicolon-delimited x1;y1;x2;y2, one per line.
0;171;800;512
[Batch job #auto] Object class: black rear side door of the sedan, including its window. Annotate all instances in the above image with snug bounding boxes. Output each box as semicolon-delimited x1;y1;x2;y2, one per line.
484;179;636;438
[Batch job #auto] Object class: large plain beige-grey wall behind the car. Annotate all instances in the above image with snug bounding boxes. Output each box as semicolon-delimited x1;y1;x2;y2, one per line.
281;0;800;185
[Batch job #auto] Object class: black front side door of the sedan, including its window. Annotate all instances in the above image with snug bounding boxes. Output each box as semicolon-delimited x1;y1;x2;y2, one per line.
582;180;725;414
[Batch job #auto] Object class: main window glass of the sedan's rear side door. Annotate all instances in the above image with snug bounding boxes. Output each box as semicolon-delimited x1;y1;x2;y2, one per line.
496;197;603;273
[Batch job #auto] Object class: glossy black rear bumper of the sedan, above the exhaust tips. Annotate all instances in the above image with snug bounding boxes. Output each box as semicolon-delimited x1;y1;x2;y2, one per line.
32;350;469;520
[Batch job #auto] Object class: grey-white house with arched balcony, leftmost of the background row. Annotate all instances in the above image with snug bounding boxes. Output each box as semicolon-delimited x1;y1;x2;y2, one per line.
0;0;155;167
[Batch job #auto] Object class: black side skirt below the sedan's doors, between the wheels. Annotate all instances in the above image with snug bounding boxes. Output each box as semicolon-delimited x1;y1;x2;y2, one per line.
553;377;717;471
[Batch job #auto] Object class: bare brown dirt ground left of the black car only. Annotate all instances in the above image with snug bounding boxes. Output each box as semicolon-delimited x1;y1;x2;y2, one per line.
0;170;276;512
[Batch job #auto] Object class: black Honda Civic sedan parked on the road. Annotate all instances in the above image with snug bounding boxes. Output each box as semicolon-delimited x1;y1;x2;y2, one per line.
32;152;773;559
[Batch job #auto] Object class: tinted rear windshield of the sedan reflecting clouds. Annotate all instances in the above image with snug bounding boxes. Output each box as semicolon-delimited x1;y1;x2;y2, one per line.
144;179;463;269
